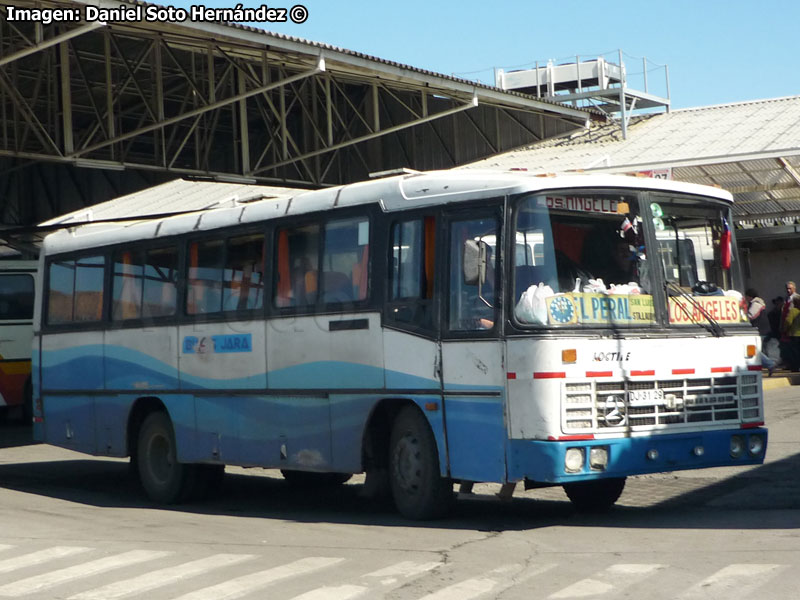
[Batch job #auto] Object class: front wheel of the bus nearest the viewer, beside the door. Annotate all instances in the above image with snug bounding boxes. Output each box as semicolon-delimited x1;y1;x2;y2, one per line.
389;407;453;520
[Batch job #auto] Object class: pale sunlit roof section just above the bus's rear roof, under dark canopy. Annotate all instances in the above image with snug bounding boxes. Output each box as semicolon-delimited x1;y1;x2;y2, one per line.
42;179;306;225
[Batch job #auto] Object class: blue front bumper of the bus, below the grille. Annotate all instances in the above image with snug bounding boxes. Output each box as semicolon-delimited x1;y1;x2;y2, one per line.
508;428;767;484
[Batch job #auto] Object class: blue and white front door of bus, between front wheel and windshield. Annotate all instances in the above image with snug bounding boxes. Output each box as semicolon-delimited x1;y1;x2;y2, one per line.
440;207;506;481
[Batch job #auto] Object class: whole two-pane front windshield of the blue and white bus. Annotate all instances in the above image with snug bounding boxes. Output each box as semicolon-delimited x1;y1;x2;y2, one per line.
512;192;743;327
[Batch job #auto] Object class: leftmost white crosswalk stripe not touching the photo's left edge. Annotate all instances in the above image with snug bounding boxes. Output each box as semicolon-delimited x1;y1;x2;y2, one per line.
69;554;255;600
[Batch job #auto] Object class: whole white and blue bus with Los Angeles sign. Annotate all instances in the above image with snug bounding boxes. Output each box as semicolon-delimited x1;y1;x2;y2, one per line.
34;171;767;519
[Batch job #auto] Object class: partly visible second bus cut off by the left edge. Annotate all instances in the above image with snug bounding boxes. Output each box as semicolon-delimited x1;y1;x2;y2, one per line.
0;260;36;423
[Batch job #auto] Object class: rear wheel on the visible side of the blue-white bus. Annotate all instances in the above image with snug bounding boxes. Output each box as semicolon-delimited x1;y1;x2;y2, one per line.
136;411;196;504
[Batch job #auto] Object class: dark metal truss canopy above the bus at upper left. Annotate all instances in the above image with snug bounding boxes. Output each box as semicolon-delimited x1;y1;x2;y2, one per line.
0;0;600;223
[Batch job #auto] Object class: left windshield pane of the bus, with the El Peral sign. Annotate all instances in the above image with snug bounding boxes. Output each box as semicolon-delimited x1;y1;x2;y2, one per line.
514;193;655;326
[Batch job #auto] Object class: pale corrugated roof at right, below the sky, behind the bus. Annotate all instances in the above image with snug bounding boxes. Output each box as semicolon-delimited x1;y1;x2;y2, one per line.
464;96;800;223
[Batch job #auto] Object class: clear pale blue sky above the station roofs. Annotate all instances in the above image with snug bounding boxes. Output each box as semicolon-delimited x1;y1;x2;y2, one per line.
166;0;800;108
